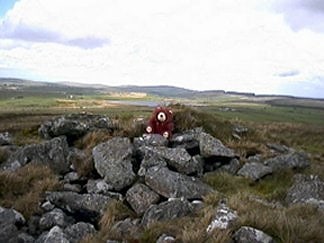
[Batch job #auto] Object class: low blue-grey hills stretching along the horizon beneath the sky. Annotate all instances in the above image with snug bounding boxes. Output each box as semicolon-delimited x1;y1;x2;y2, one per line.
0;78;324;106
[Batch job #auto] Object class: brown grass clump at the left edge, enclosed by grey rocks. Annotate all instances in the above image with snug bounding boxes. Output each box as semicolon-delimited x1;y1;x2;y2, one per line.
0;164;60;218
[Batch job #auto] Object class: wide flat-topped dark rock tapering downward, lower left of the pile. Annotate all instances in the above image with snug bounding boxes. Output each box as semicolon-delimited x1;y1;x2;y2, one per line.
46;192;111;220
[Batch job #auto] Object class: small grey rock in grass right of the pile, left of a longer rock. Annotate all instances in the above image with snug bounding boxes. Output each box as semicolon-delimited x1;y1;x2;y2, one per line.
237;162;272;181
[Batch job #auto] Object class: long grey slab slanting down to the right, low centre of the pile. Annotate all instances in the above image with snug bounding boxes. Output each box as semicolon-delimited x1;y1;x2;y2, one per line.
145;166;213;199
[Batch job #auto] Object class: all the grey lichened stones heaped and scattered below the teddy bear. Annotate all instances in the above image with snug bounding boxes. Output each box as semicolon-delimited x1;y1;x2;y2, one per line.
0;115;318;242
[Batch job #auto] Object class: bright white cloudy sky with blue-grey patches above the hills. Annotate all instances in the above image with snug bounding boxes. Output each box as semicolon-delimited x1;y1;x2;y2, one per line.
0;0;324;98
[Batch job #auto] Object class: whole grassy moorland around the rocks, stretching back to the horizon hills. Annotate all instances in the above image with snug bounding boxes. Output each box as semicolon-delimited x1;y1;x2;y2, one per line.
0;78;324;242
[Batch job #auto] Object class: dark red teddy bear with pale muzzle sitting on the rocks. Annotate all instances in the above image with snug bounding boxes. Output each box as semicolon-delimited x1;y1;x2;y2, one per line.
146;106;174;138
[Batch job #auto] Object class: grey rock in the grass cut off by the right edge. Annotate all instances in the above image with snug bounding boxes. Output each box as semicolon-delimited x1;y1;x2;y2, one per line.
285;174;324;209
